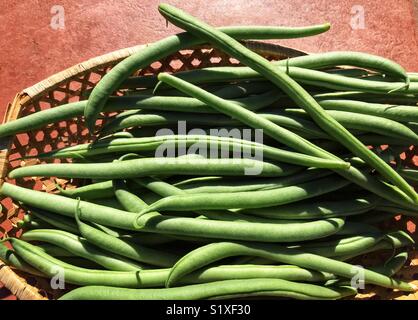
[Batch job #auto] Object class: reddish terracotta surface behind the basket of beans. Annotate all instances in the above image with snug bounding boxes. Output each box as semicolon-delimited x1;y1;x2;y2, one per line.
0;0;418;117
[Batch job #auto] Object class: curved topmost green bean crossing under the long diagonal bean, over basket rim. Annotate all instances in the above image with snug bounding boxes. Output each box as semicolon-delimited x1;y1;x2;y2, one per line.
84;24;330;131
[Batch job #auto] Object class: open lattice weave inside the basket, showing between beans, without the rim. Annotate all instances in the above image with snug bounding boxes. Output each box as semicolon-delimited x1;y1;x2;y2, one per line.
0;46;418;299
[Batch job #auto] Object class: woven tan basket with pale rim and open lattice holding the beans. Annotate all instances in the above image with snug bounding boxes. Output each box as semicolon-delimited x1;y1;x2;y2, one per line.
0;42;418;299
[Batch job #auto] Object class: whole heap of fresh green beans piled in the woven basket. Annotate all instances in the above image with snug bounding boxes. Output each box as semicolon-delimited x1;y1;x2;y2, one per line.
0;4;418;300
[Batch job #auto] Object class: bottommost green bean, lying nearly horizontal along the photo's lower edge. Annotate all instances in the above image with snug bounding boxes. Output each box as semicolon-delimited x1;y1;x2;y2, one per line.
60;279;356;300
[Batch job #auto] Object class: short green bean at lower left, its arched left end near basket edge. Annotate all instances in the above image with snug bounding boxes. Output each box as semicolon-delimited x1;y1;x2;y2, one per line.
21;229;142;271
